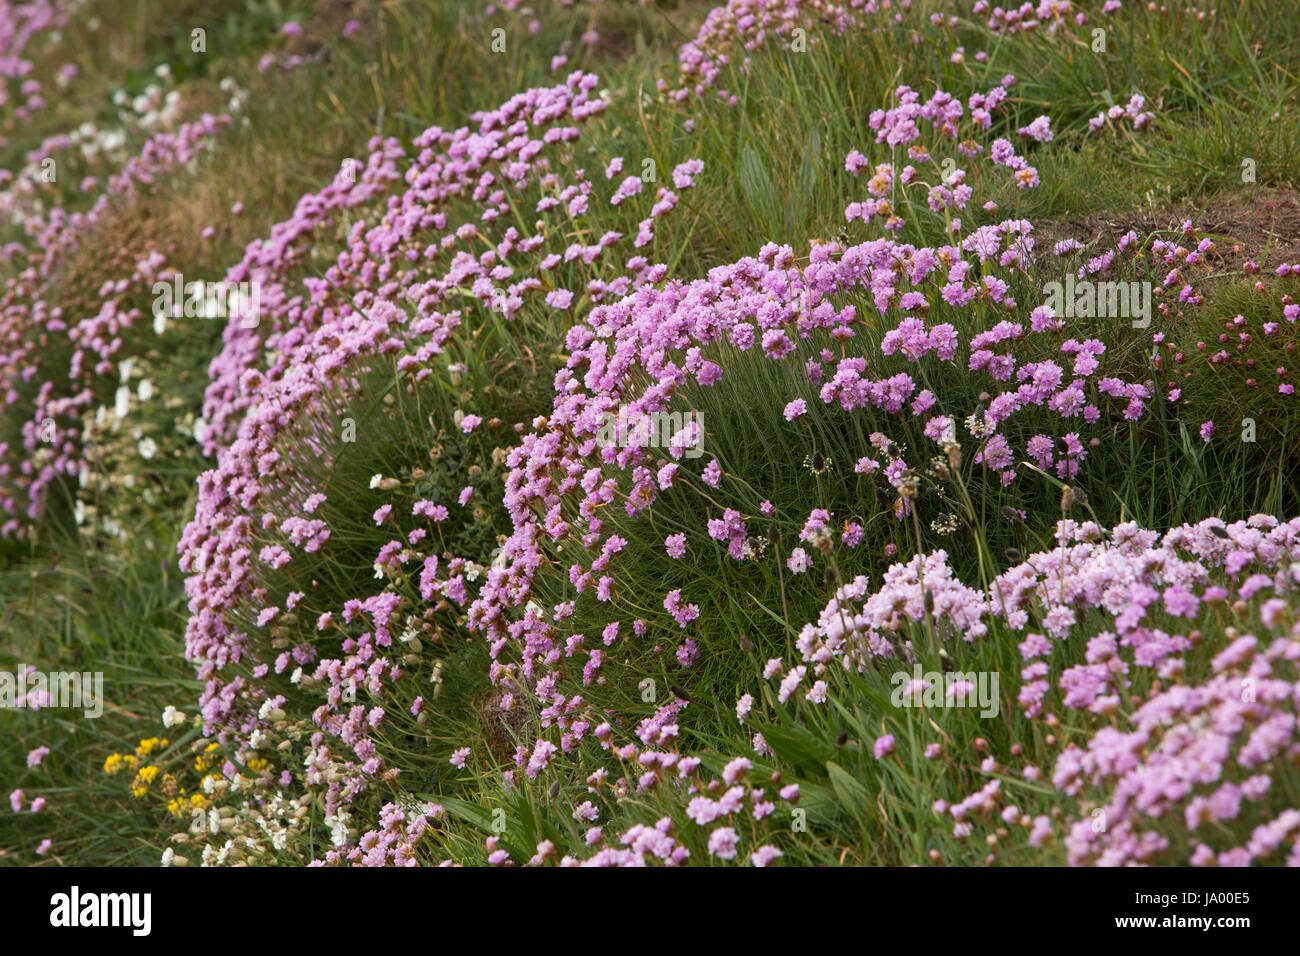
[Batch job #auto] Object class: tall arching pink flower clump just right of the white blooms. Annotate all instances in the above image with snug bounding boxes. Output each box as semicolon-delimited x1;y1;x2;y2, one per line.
179;73;702;842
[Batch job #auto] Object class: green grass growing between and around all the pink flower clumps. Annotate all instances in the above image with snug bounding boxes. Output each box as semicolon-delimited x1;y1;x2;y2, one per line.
0;0;1300;865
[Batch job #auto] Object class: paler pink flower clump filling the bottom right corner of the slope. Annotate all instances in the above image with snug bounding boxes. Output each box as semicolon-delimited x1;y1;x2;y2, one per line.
790;515;1300;866
